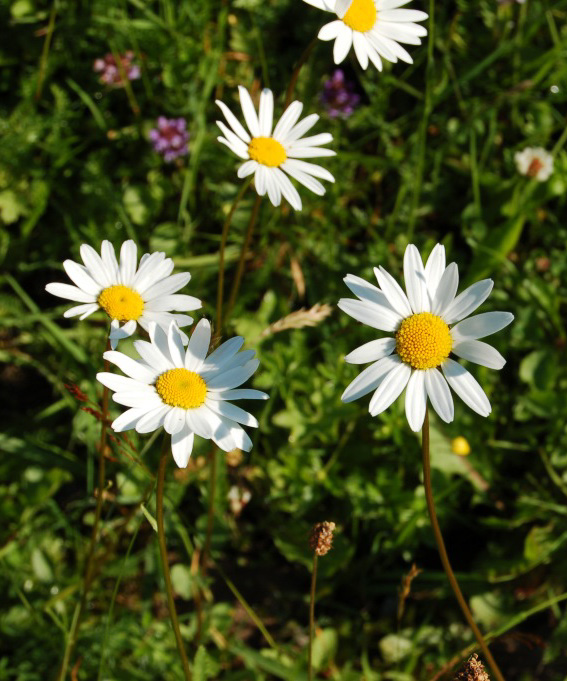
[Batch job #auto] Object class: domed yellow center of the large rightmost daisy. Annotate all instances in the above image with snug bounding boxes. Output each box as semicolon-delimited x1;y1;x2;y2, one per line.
396;312;453;369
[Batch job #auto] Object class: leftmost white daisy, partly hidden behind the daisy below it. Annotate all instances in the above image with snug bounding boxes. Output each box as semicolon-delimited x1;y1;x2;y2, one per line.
45;240;201;350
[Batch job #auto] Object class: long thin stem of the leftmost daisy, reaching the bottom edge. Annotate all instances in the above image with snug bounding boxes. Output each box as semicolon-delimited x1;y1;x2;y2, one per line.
57;339;110;681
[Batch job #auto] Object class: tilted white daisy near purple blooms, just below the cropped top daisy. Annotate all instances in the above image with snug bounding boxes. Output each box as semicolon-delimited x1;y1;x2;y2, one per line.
216;85;335;210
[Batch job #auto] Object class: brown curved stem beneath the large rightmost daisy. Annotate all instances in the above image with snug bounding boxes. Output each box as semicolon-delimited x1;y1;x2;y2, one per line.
422;410;504;681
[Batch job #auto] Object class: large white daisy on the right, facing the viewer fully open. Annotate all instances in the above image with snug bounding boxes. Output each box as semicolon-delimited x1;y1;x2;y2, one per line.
339;244;514;431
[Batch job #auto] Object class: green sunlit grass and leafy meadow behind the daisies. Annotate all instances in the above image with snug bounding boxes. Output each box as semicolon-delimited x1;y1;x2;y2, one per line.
0;0;567;681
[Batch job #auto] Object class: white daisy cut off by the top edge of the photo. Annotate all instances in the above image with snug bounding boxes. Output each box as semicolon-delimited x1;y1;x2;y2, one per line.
305;0;427;71
